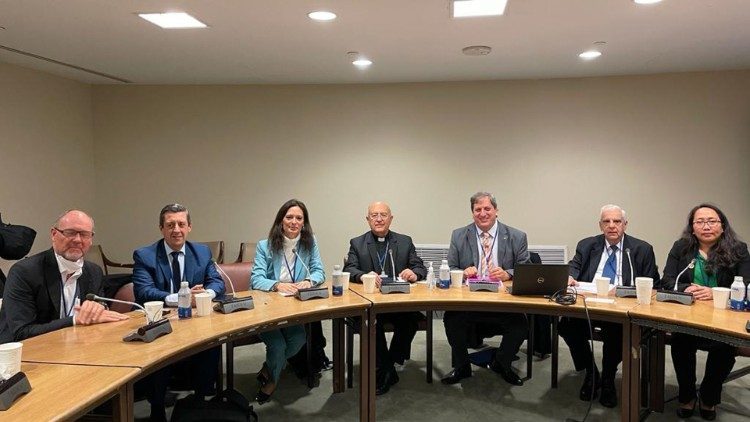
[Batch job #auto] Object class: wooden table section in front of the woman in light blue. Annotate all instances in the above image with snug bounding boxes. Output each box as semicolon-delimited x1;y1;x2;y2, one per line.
15;291;370;420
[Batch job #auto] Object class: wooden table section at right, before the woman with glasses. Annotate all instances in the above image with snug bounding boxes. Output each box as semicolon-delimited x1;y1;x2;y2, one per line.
629;300;750;412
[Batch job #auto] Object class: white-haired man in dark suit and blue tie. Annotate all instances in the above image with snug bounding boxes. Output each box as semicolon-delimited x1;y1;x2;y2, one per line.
559;205;659;407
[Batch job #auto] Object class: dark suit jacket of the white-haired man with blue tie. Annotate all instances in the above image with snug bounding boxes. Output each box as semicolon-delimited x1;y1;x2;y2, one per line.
568;234;659;286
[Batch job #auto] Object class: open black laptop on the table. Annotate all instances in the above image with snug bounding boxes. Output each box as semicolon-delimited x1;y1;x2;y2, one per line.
509;264;568;296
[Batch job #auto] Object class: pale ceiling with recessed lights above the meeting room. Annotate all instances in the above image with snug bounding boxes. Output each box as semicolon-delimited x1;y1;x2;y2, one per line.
0;0;750;84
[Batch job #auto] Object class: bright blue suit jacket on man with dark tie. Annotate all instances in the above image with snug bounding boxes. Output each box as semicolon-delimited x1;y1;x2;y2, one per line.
133;239;225;304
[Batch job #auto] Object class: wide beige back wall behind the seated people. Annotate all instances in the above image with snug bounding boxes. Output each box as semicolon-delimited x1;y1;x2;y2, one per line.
91;71;750;271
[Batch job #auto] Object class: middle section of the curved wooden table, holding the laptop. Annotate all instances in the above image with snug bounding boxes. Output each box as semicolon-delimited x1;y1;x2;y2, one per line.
349;283;639;421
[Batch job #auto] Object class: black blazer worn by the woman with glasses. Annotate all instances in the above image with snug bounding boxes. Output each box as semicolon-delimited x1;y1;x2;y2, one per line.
661;239;750;291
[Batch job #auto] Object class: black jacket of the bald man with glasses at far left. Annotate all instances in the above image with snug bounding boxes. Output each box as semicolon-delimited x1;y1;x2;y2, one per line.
0;248;103;343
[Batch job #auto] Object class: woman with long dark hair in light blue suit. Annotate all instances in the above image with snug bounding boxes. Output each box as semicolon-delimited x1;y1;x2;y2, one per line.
250;199;325;404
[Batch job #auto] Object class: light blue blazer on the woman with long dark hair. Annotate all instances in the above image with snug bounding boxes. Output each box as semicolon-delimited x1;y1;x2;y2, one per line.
250;239;326;292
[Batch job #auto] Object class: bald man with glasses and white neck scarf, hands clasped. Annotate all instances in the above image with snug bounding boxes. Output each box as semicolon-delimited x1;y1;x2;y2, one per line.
0;210;128;343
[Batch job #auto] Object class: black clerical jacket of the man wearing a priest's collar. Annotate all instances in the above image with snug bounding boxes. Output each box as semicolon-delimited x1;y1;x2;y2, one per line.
344;231;427;283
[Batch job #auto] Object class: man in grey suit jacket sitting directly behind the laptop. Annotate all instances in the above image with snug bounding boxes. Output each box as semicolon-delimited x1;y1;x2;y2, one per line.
441;192;529;385
